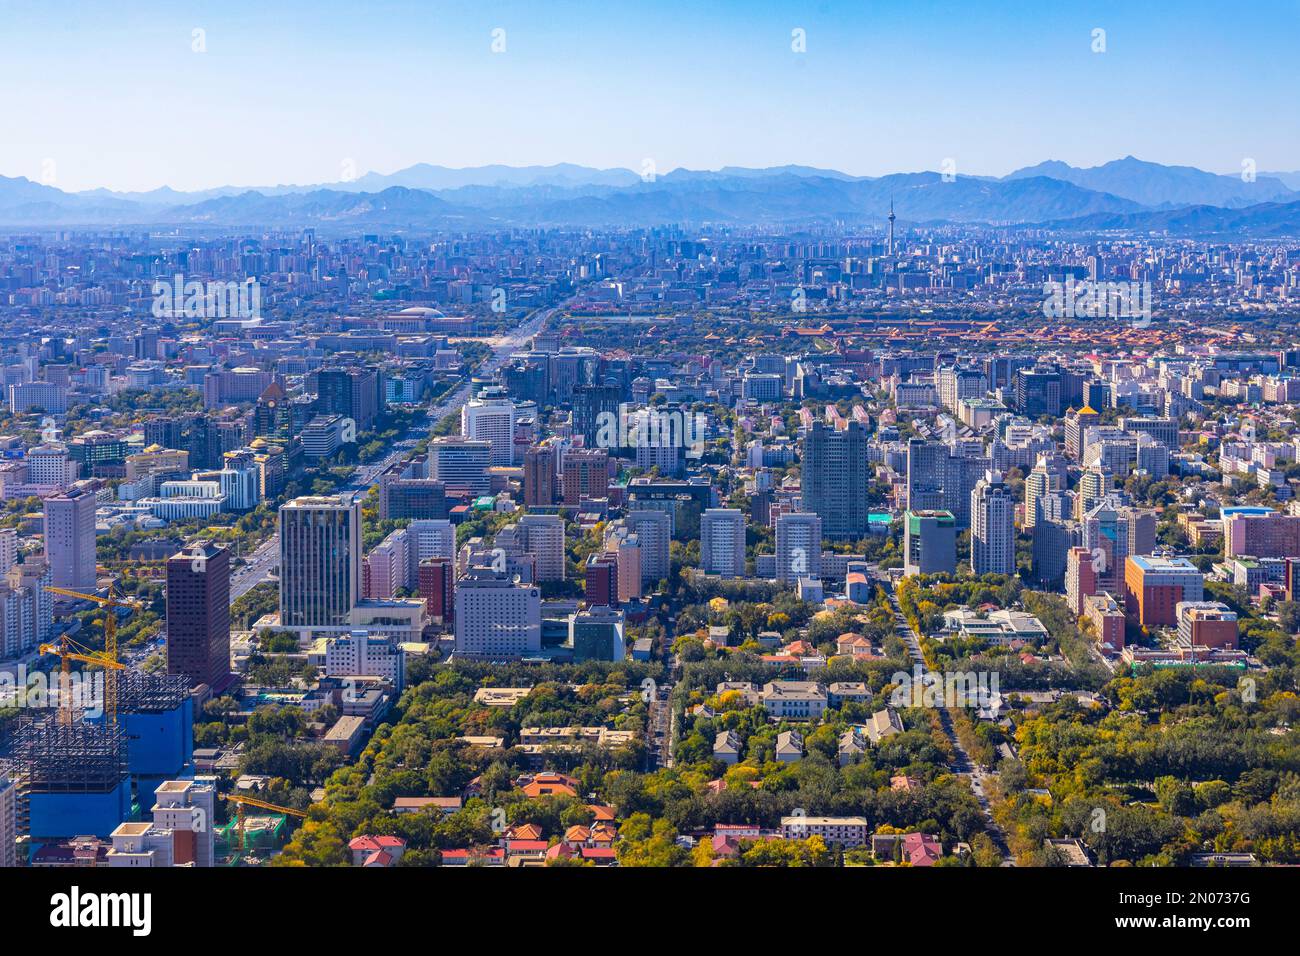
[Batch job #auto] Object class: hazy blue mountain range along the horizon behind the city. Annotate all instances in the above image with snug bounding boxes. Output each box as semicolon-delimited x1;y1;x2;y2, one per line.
0;156;1300;237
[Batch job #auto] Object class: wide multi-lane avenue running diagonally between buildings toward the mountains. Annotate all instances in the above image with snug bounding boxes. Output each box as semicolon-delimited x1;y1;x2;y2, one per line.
230;307;551;604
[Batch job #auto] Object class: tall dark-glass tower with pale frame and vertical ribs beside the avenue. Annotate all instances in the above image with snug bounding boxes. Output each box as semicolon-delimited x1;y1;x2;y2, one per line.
280;496;361;630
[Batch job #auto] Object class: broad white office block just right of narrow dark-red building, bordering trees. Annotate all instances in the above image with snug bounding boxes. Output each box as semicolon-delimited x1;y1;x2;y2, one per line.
455;567;542;658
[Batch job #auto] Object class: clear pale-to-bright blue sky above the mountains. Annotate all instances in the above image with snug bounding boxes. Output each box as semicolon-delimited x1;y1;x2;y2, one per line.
0;0;1300;191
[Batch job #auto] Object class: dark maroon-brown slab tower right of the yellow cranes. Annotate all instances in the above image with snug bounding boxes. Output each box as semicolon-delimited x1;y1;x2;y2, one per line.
166;541;230;688
